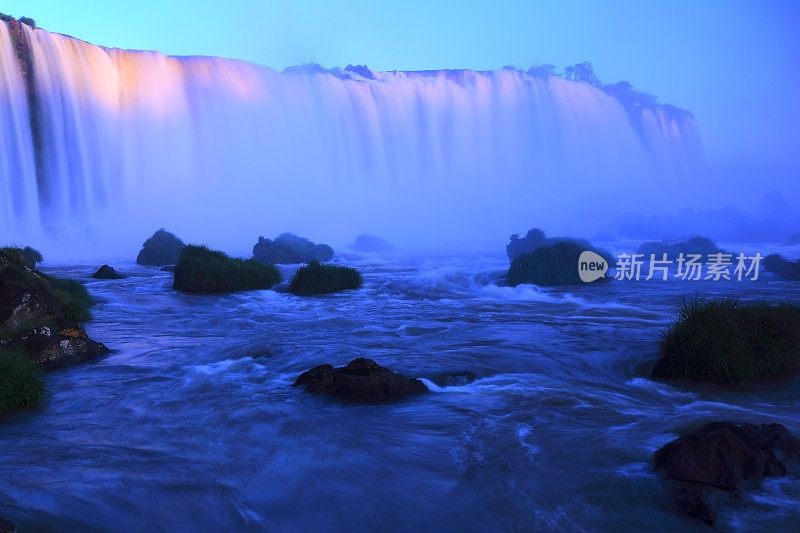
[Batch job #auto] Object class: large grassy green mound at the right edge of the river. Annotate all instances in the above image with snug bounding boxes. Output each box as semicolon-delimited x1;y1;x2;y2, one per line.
652;298;800;383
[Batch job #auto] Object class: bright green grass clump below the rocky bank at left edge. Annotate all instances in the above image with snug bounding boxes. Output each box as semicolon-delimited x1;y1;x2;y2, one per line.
0;347;47;415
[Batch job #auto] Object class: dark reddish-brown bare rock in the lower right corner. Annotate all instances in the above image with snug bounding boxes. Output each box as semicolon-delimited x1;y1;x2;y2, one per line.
653;422;800;525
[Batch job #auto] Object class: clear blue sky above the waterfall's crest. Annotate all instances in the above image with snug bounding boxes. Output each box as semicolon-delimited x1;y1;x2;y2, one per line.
6;0;800;177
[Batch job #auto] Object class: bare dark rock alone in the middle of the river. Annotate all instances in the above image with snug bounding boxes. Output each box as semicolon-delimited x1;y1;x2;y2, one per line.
292;357;428;402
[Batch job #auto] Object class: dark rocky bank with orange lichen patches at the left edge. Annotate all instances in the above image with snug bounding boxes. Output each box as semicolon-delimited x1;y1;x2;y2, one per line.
0;248;108;366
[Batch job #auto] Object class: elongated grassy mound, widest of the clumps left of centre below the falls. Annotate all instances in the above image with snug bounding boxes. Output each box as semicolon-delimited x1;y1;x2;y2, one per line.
172;245;281;294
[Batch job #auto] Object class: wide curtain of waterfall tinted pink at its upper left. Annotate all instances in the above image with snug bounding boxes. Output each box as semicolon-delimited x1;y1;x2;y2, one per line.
0;23;701;254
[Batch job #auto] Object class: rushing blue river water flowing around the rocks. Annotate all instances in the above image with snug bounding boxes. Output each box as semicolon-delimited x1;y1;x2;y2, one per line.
0;248;800;531
